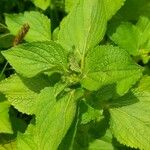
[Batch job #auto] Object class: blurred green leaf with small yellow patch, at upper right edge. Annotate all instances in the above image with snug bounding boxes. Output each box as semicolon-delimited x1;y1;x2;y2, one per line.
108;17;150;63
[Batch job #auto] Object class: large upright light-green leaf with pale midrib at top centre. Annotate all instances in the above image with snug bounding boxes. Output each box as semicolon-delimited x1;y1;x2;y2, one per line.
58;0;123;63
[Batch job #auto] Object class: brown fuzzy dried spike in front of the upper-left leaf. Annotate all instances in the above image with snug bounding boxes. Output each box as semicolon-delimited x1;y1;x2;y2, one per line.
13;23;30;46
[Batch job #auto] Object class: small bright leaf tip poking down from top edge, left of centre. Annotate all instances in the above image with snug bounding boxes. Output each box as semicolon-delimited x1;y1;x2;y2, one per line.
32;0;51;10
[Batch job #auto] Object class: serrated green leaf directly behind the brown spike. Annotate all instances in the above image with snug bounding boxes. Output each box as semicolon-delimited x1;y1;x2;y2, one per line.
5;11;51;42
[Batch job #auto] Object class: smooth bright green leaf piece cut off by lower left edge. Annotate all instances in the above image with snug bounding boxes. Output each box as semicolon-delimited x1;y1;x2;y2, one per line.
0;98;13;134
